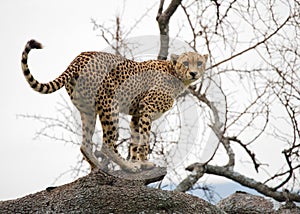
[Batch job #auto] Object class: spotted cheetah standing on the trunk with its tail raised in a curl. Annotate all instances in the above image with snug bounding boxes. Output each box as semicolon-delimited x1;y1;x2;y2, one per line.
21;40;208;172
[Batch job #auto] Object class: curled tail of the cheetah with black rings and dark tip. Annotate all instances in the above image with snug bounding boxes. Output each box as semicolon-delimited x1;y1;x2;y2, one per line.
21;40;69;94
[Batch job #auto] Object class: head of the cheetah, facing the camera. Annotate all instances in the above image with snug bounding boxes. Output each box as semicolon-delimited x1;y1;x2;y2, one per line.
171;52;208;85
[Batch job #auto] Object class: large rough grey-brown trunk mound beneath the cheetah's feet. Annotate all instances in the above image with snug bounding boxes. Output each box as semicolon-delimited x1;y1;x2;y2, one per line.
0;170;223;213
